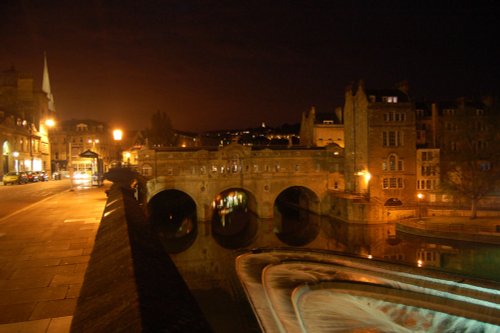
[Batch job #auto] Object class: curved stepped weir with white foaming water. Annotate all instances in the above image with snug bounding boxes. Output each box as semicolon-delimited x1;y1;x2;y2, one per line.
236;249;500;333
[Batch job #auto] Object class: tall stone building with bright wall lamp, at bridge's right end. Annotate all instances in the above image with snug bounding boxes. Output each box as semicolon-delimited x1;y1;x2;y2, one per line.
344;82;416;206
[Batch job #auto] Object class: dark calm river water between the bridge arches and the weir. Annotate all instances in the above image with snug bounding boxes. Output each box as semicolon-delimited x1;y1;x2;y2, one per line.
160;206;500;332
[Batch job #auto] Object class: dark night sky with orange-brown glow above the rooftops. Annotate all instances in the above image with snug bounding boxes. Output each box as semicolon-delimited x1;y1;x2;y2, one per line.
0;0;500;131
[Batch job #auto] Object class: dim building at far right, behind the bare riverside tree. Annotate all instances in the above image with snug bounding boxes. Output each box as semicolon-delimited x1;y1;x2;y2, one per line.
417;98;500;209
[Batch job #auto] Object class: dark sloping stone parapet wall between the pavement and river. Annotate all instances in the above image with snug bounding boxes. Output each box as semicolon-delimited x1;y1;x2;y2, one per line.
71;171;211;333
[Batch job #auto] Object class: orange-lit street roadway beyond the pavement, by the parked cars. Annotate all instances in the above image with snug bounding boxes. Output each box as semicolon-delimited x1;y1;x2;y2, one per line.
0;179;77;219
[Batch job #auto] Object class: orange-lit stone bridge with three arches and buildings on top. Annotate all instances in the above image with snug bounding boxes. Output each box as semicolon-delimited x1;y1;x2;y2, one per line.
139;143;344;221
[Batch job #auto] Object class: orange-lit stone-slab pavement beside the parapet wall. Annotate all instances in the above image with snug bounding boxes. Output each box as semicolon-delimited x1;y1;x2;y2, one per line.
0;184;109;333
